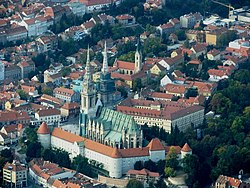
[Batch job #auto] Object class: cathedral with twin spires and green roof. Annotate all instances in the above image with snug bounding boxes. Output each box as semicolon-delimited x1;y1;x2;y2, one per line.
79;44;143;149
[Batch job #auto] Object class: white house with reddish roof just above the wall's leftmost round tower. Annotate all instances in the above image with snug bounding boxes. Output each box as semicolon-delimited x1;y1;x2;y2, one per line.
31;109;61;125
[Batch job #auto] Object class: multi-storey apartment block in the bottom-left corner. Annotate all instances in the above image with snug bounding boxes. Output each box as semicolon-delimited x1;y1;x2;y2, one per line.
3;160;28;188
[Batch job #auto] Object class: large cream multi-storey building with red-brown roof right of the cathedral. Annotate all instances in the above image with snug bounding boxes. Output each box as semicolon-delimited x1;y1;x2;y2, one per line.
117;99;204;132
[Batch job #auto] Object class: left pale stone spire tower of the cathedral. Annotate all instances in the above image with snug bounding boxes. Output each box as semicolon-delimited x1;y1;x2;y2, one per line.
81;47;96;116
